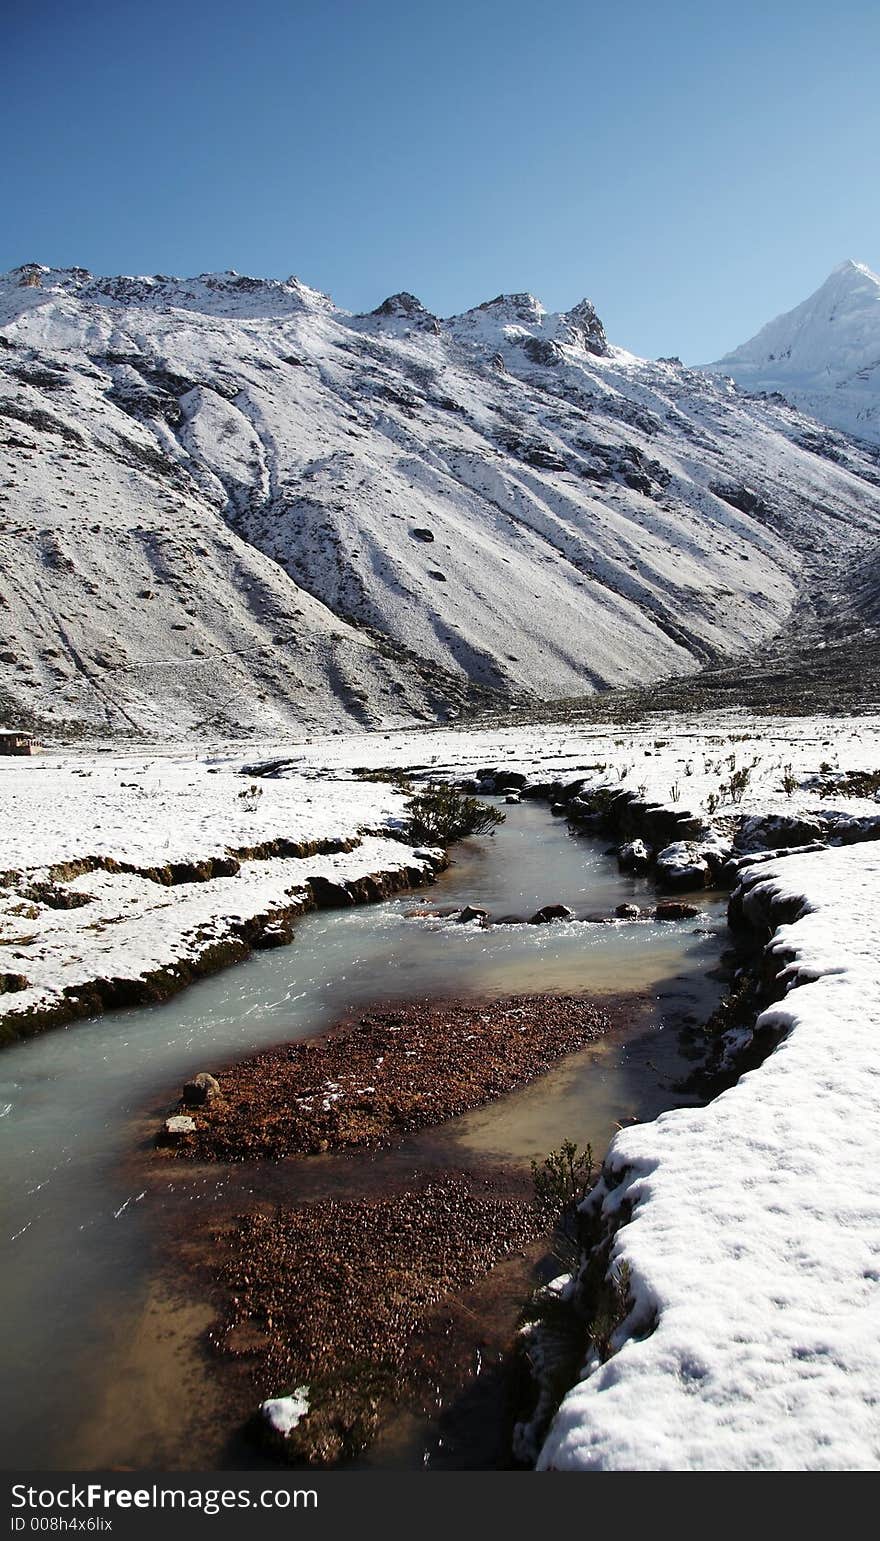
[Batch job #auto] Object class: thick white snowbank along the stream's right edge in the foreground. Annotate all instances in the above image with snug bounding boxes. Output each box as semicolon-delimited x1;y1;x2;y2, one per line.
539;844;880;1470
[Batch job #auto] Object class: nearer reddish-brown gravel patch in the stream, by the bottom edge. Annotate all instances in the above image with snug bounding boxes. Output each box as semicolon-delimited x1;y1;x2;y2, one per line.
211;1173;546;1464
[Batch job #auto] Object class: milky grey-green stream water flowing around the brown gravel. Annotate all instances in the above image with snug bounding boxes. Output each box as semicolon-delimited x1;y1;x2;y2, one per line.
0;803;726;1470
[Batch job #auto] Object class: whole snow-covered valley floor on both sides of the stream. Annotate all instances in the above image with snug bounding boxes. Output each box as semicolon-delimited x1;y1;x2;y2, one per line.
0;712;880;1470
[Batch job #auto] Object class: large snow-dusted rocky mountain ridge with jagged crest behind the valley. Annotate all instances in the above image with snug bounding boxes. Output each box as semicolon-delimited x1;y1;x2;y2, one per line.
0;267;880;737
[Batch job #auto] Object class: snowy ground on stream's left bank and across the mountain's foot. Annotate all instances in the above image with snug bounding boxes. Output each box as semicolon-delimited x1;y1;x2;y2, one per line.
0;713;880;1022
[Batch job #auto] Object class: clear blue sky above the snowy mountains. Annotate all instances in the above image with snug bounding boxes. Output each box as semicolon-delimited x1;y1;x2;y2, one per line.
0;0;880;362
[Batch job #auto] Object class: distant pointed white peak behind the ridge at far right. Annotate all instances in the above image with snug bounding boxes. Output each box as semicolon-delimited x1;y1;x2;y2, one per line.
707;262;880;444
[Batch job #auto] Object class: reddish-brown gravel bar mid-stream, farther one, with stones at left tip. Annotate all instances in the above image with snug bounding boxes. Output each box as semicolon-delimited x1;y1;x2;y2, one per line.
173;995;610;1160
